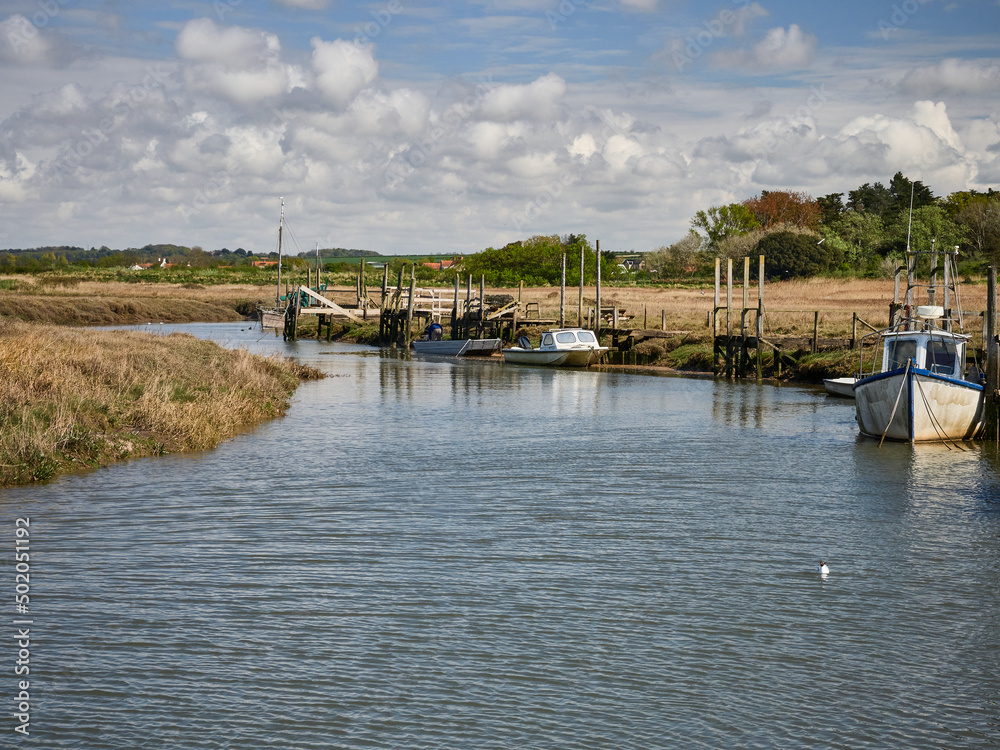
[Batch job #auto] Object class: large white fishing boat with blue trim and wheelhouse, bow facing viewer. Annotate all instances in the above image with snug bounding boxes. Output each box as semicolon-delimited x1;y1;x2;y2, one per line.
854;248;984;443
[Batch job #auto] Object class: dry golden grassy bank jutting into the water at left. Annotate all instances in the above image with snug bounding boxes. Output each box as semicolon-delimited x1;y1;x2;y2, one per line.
0;318;322;486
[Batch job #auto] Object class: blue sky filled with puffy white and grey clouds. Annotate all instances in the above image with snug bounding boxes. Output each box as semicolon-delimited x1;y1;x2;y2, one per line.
0;0;1000;254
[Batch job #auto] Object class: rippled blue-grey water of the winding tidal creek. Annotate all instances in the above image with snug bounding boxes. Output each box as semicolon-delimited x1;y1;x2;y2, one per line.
0;325;1000;750
